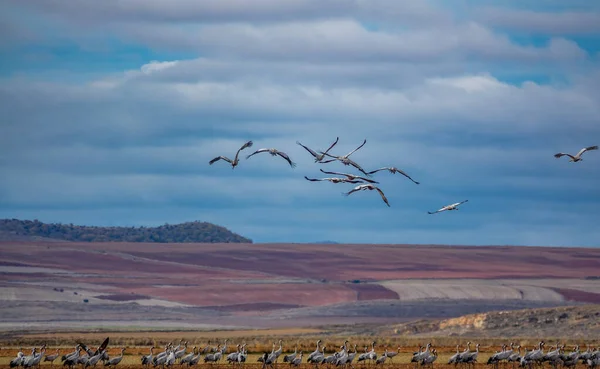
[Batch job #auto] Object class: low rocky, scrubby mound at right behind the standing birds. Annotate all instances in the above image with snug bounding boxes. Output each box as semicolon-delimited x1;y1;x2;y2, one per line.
393;305;600;338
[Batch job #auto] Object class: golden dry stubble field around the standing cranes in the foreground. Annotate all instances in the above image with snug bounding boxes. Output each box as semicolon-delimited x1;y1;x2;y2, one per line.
0;328;597;369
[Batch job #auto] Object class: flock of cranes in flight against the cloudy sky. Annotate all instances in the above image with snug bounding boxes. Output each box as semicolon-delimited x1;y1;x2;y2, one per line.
209;137;598;214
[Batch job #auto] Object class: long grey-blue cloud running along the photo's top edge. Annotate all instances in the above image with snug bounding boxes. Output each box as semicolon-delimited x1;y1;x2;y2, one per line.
10;0;448;24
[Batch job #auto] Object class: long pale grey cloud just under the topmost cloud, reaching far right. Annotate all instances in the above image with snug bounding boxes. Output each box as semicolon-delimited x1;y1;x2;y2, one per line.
108;19;586;63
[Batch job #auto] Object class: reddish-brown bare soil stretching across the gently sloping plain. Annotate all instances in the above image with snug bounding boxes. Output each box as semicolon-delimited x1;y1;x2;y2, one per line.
0;242;600;311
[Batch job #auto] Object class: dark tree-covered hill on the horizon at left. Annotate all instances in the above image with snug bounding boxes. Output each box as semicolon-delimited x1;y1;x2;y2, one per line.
0;219;252;243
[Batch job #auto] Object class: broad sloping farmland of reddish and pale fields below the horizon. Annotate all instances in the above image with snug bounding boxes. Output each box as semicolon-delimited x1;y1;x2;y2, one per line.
0;241;600;332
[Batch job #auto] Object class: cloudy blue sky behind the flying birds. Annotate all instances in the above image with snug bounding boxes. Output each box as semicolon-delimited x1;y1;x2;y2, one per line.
0;0;600;247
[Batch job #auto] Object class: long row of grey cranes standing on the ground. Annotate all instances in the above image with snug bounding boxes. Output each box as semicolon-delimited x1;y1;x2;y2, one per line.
10;338;600;369
